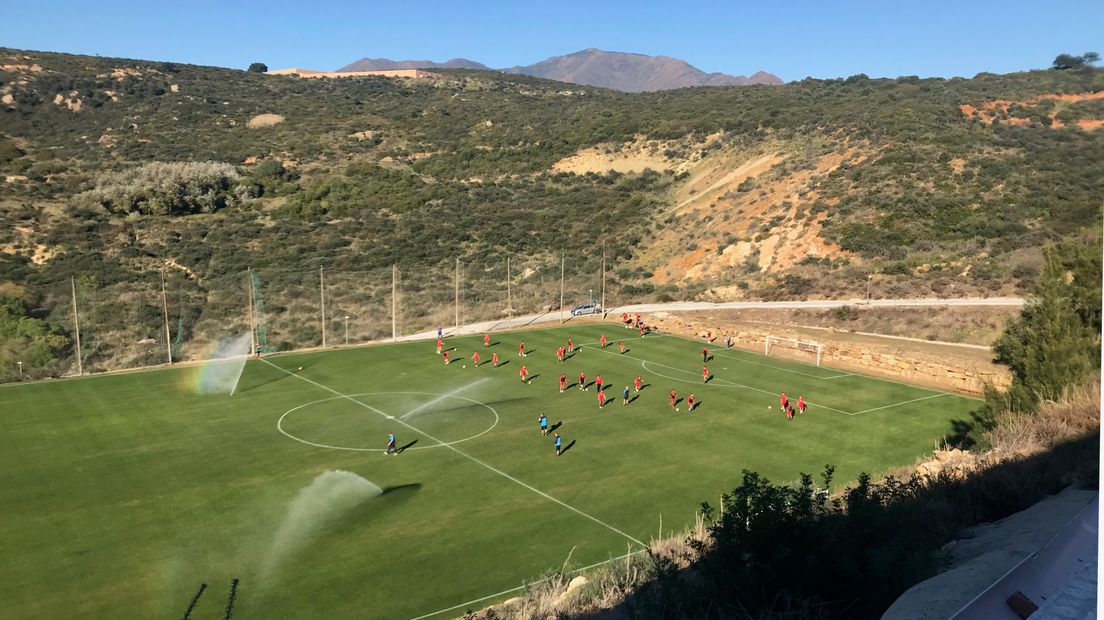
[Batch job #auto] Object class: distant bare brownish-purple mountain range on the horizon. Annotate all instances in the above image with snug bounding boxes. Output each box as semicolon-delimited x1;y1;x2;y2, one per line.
338;47;783;93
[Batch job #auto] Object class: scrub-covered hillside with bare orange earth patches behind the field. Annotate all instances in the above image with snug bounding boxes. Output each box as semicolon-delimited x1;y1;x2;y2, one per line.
0;45;1104;375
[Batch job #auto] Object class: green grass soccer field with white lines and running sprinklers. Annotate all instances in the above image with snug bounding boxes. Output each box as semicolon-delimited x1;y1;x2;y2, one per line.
0;323;977;619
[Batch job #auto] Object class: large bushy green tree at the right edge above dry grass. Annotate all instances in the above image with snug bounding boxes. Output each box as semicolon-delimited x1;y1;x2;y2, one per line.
990;237;1101;411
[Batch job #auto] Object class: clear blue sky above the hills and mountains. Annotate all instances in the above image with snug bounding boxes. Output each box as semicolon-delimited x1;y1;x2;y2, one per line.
0;0;1104;81
